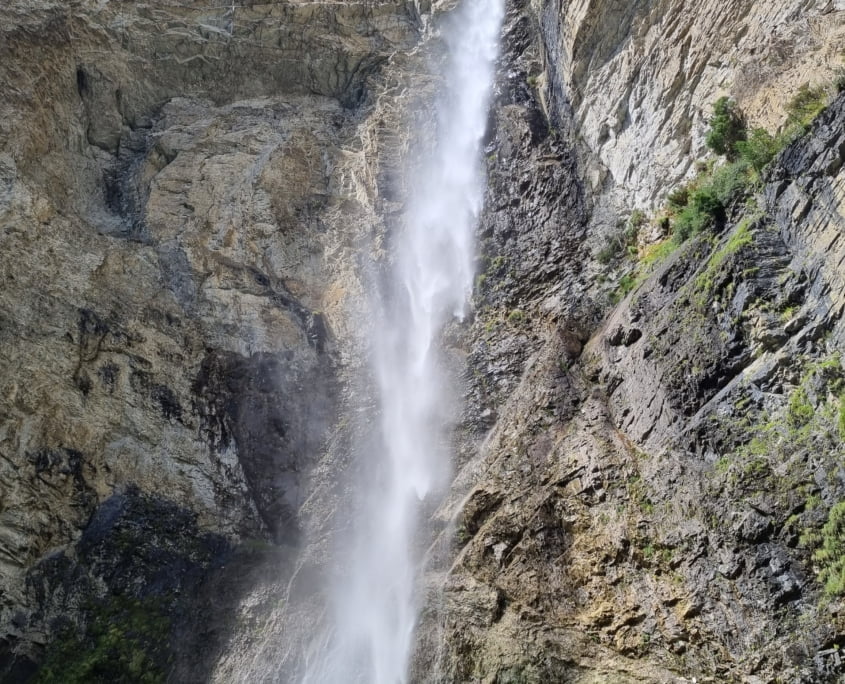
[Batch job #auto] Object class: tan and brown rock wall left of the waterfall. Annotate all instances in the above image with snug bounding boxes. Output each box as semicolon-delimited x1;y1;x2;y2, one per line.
0;2;419;681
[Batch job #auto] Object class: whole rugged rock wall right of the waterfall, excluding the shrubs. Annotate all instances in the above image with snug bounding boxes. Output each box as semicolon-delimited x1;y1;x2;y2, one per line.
421;2;845;682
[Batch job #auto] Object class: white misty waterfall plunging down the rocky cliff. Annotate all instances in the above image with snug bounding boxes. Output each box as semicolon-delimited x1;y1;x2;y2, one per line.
303;0;504;684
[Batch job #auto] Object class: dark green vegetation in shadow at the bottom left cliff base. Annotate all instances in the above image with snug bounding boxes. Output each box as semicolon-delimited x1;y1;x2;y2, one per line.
34;597;170;684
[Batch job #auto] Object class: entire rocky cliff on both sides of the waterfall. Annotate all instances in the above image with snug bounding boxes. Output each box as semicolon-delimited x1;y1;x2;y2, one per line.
0;0;845;683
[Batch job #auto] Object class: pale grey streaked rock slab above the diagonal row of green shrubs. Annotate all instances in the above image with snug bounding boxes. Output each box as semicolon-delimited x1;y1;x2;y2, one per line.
532;0;845;206
